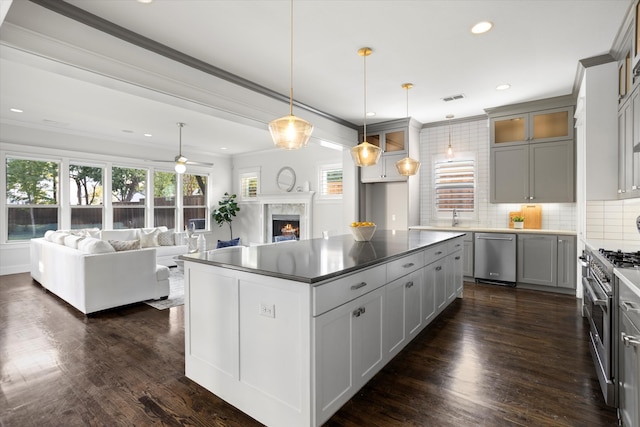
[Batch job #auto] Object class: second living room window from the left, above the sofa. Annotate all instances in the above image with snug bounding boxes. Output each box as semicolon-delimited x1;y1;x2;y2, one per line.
69;164;103;228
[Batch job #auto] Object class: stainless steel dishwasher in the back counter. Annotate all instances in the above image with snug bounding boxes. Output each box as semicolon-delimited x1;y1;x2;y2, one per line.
473;233;516;286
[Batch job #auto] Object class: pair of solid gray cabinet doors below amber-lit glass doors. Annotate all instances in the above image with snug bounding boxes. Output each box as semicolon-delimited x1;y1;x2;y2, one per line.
490;140;575;203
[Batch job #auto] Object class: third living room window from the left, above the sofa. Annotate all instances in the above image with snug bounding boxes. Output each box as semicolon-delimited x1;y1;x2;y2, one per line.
111;166;147;229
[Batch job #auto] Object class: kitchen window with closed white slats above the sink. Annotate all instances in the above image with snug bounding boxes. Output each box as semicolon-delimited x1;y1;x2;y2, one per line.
434;159;475;216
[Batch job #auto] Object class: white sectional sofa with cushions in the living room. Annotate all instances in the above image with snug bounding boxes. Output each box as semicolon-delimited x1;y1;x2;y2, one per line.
30;230;188;314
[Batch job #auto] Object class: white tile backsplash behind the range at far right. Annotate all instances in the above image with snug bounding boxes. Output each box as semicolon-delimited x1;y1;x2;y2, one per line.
586;198;640;242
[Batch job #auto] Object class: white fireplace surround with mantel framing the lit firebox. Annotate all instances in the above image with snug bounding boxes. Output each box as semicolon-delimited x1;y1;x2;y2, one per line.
257;191;315;243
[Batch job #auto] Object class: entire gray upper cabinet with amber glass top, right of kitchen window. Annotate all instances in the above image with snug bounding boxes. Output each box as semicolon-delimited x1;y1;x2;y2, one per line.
488;98;575;203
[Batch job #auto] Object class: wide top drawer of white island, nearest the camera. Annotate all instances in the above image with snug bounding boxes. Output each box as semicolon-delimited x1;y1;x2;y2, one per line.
313;264;387;316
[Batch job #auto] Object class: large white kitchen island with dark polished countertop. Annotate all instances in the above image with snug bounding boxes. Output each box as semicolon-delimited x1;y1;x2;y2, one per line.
181;230;464;426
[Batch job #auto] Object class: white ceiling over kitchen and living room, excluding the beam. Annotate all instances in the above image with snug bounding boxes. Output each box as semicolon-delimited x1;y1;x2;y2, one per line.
0;0;632;157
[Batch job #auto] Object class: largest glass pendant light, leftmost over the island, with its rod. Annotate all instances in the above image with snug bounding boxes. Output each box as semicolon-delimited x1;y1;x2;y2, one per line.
269;0;313;150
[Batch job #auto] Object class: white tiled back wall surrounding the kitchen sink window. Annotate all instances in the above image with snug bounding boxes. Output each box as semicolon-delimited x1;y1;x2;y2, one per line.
420;118;576;231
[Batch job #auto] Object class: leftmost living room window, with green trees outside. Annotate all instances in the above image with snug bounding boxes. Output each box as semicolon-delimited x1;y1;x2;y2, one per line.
6;157;59;240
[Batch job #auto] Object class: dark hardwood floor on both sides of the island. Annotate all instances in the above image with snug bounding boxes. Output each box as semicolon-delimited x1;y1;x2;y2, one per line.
0;274;617;427
